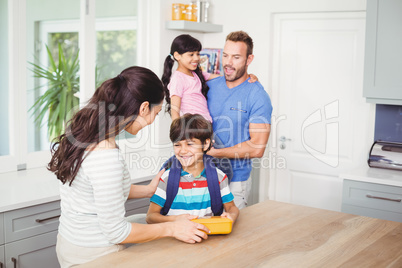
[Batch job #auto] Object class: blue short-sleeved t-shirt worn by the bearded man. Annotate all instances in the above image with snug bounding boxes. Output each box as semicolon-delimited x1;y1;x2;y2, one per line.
207;76;272;181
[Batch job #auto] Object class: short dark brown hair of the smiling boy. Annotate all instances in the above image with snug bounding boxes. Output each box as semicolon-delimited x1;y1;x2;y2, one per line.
170;114;213;151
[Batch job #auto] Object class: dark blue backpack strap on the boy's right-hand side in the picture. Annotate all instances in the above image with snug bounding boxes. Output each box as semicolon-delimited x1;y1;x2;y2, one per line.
204;154;223;216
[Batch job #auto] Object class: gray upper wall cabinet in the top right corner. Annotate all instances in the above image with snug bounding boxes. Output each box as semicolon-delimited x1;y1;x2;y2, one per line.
363;0;402;105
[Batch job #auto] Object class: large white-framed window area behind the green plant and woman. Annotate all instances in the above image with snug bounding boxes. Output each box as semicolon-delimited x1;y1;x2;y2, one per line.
0;0;141;172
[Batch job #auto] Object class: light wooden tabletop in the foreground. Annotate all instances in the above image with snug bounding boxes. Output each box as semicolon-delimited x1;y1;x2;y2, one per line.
80;201;402;268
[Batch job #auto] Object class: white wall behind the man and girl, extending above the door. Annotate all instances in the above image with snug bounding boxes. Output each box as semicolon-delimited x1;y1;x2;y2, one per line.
155;0;366;144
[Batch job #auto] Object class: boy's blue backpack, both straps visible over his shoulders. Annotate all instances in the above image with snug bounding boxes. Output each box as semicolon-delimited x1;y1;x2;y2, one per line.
161;154;223;216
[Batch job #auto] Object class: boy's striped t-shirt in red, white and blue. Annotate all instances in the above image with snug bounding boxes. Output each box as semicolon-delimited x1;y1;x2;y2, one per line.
151;169;234;217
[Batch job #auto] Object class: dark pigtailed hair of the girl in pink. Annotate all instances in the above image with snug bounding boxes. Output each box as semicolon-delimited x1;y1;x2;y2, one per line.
162;34;209;113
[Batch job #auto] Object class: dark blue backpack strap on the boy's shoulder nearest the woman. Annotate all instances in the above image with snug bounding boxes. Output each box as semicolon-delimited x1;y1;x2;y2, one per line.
161;156;181;215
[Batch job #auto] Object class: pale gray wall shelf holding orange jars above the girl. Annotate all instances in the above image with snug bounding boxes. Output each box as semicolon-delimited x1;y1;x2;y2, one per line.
166;20;223;33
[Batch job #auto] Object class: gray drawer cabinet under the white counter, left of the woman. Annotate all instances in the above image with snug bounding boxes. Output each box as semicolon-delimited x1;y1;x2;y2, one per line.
4;201;60;268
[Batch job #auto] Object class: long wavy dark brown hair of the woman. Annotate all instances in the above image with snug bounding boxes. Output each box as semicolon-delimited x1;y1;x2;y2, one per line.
48;67;164;186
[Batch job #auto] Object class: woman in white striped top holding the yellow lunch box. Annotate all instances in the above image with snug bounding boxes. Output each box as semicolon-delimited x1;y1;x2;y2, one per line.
48;67;208;267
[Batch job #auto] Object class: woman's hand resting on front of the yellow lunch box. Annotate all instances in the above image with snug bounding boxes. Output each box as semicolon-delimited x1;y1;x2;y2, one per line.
171;221;210;244
